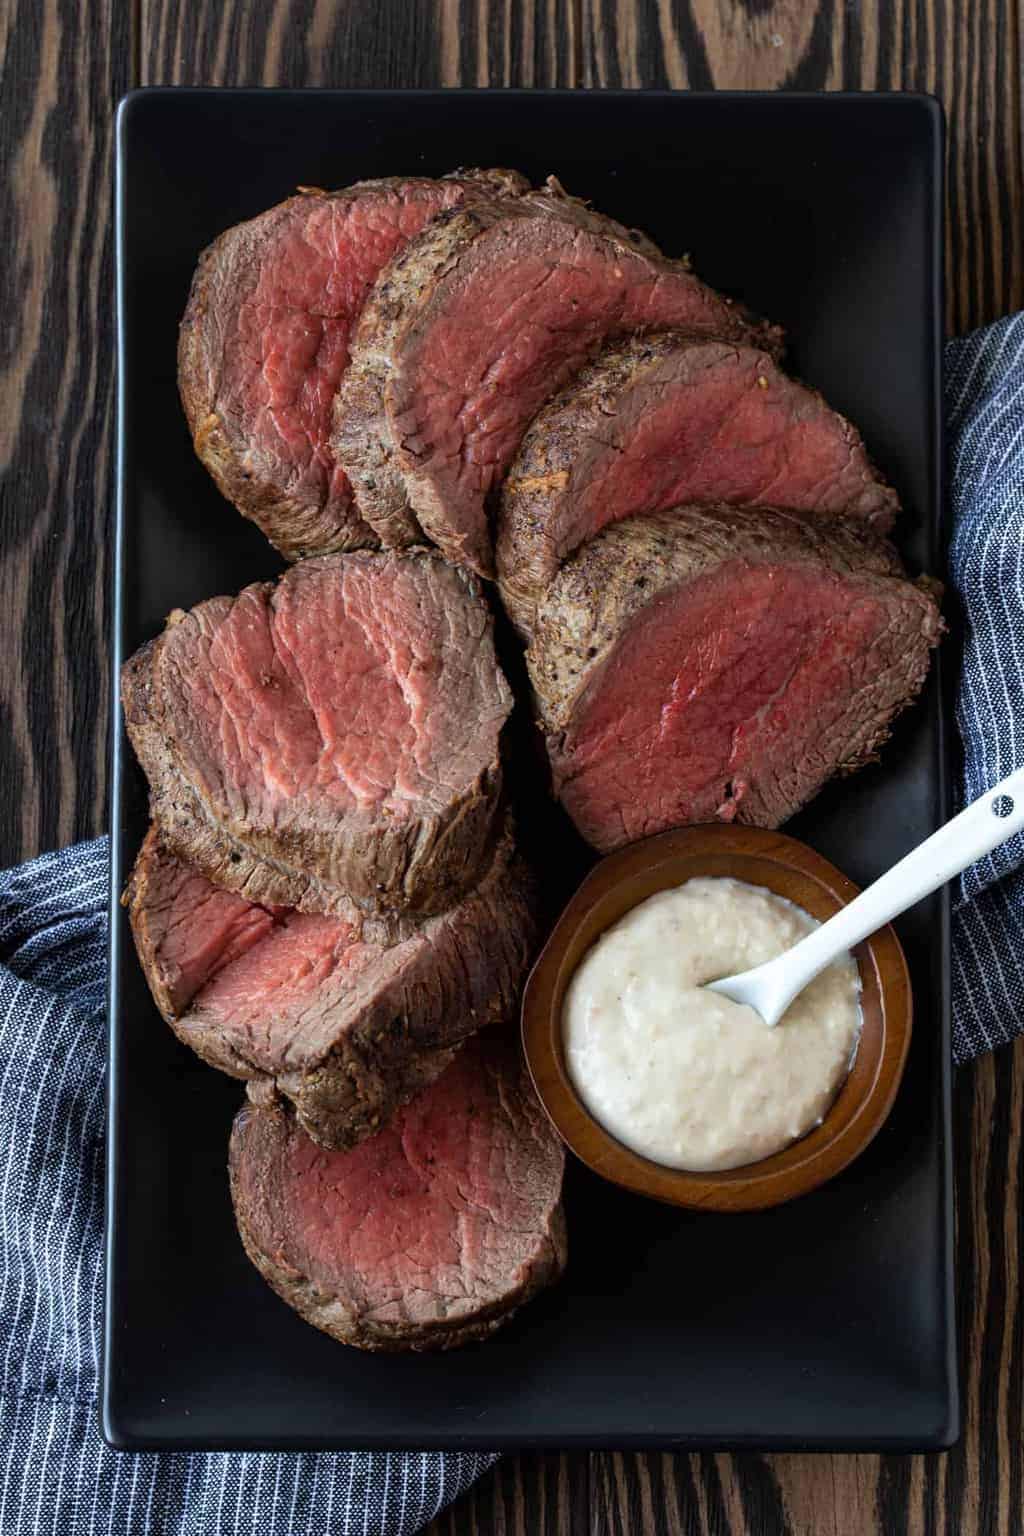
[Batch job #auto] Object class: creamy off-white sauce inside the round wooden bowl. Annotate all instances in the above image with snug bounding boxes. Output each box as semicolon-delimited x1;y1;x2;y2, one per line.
562;879;861;1170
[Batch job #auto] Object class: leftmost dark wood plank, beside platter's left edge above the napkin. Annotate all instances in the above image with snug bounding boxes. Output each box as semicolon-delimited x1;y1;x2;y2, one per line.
0;0;132;865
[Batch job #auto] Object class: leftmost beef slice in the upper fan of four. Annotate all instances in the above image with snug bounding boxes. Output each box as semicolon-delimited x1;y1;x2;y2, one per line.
178;170;527;559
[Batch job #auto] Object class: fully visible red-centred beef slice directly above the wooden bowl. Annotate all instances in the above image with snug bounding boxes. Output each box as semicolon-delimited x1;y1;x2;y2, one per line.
527;507;943;851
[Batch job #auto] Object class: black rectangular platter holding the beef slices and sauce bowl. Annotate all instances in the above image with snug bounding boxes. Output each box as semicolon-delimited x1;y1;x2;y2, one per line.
101;91;958;1450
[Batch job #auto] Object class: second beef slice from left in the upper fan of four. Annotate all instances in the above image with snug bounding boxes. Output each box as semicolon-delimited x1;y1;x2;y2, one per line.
333;190;778;574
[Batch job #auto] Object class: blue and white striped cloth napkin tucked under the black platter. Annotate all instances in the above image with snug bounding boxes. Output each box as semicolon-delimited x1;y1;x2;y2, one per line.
0;316;1024;1536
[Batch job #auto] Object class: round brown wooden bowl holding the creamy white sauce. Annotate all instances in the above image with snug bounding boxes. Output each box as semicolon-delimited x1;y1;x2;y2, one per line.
522;825;912;1210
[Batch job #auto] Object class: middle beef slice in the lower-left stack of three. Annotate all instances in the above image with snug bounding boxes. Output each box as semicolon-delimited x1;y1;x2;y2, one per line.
126;829;536;1147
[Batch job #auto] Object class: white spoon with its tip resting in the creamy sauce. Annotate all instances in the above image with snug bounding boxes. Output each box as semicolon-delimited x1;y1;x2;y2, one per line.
708;768;1024;1028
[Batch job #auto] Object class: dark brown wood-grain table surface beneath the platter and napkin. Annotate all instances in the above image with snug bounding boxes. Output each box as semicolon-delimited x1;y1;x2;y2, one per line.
0;0;1024;1536
